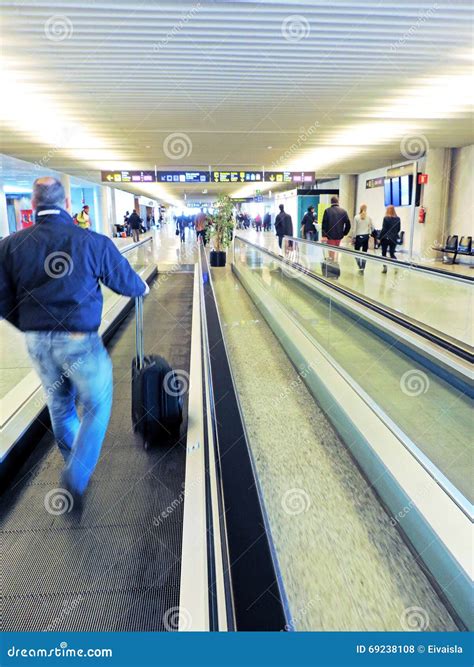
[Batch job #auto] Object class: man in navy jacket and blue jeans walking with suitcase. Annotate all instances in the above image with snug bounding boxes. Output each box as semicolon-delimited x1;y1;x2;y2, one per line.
0;177;149;506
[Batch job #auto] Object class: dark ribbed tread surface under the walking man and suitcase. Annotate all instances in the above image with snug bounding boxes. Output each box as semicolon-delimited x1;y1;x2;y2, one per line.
0;274;193;631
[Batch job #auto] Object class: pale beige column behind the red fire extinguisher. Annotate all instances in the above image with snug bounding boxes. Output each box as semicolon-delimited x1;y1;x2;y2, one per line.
414;148;452;259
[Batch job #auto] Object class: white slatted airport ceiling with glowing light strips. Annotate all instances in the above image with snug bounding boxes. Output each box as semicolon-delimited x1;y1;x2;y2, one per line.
0;0;473;198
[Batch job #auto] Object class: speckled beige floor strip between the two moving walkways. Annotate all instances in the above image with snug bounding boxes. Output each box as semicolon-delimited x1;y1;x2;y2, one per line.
212;269;457;631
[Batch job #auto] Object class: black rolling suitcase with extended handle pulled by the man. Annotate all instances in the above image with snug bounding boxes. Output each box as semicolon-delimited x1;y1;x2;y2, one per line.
132;297;183;448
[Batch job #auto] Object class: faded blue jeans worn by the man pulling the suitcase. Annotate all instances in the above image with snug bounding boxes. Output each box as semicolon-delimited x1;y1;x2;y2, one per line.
26;331;113;494
